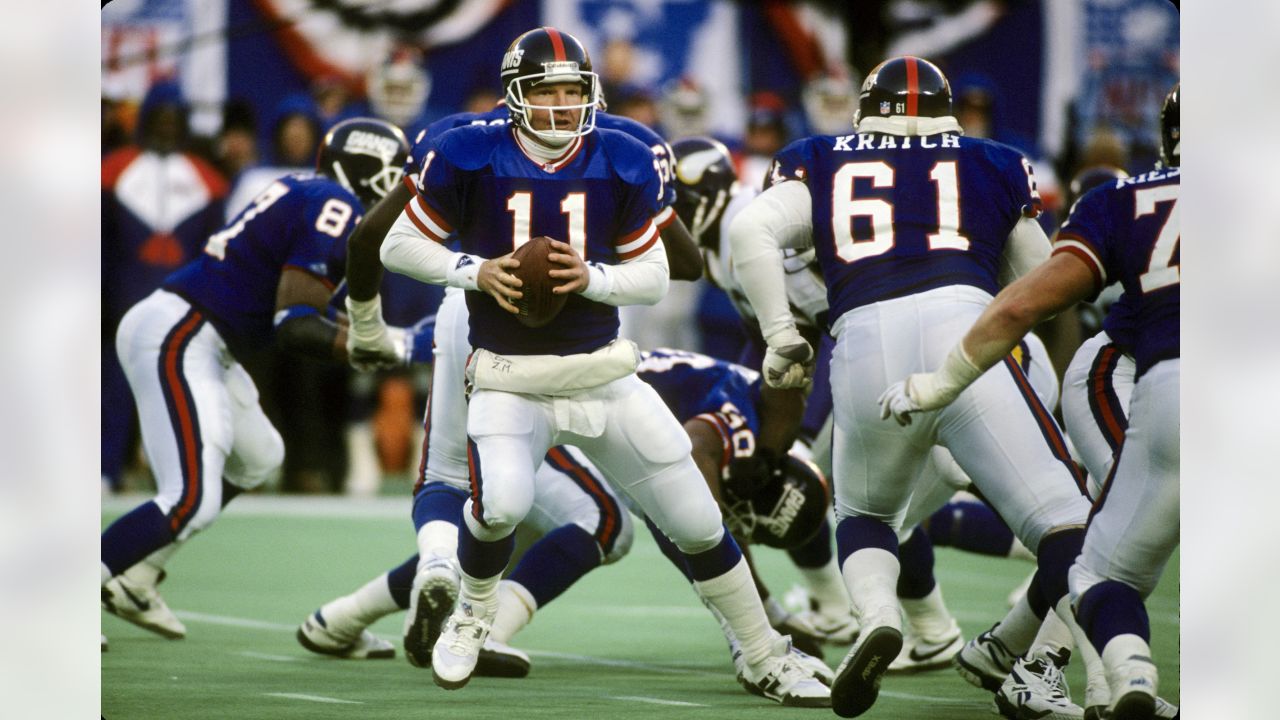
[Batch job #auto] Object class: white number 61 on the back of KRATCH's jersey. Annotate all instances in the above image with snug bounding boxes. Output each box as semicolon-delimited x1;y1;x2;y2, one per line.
831;160;969;263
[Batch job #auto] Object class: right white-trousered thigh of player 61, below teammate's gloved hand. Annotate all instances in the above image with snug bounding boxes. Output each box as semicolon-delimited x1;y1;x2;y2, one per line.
938;361;1089;552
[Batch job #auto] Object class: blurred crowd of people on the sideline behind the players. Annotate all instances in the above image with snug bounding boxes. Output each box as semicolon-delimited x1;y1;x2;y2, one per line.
102;3;1178;493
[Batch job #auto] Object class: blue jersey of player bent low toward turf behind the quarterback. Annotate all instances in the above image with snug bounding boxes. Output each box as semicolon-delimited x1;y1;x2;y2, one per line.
636;347;760;434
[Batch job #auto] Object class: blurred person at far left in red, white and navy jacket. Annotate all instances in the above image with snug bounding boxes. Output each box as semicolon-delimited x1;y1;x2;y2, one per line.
101;81;227;489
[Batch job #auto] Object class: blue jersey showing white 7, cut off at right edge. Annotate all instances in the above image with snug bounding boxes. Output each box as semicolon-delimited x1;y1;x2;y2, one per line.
1053;168;1181;377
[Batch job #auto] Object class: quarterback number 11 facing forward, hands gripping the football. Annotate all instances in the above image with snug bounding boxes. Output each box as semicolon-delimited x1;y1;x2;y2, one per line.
348;28;828;706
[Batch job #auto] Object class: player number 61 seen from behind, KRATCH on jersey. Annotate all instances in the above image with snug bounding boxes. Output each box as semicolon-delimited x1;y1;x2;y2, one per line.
730;56;1088;717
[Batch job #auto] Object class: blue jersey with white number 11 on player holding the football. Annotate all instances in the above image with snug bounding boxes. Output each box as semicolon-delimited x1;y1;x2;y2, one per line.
406;126;662;355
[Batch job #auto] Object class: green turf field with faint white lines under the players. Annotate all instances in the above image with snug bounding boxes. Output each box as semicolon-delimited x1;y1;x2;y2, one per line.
102;497;1179;720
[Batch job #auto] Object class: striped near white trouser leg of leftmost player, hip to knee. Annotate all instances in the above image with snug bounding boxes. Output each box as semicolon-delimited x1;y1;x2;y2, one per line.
115;291;233;538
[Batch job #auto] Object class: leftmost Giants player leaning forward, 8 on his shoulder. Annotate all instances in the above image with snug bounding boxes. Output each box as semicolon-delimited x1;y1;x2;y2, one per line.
101;119;430;638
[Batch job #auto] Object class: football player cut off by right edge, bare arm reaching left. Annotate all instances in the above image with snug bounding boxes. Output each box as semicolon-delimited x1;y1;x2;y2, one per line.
882;86;1181;720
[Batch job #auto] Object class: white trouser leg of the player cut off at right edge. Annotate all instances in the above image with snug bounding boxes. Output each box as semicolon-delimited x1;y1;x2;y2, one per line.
1070;360;1180;597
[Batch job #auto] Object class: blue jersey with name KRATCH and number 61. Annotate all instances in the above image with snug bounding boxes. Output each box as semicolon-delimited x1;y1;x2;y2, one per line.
771;133;1039;322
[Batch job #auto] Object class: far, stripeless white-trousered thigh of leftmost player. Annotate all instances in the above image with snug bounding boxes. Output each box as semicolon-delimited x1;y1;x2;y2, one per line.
223;361;284;489
